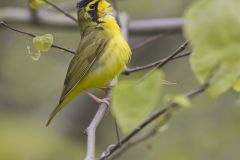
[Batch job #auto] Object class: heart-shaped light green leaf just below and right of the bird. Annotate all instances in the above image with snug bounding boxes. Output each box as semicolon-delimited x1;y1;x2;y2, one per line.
112;71;164;133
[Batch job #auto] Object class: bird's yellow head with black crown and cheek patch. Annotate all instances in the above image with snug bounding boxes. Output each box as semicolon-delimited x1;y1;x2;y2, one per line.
77;0;112;23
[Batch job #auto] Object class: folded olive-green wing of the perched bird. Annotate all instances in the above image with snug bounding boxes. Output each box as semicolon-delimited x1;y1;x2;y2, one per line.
60;30;108;103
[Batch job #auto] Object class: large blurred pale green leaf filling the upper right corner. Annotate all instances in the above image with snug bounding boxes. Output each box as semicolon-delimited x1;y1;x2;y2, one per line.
184;0;240;97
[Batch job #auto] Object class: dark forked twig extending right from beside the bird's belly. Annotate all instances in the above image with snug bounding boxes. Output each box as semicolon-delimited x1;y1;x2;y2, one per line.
122;42;191;75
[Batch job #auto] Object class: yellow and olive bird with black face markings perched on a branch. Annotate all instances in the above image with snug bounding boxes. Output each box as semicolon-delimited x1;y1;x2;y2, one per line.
46;0;132;126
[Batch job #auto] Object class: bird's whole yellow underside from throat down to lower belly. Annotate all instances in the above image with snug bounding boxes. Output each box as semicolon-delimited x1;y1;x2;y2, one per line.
75;16;131;90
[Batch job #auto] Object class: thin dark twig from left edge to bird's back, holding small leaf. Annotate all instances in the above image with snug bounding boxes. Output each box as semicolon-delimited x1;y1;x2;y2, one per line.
0;21;75;54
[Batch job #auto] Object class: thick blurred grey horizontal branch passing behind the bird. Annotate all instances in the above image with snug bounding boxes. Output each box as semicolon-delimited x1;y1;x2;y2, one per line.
0;7;184;36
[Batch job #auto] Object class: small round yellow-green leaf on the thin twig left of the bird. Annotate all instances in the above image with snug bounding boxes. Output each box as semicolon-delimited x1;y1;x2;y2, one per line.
33;34;53;52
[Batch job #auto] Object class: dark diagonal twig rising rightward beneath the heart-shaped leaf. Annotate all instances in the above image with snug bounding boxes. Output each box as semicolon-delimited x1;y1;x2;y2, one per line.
99;85;208;160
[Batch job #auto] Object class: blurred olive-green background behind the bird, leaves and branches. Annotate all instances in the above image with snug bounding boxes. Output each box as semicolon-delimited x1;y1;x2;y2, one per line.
0;0;240;160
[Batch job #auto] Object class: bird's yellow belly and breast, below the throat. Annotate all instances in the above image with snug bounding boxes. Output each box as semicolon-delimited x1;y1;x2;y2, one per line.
76;36;131;93
